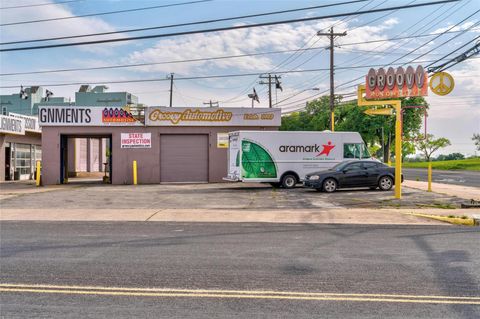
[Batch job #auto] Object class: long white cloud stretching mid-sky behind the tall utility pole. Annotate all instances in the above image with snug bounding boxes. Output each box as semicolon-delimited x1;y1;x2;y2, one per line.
123;18;398;73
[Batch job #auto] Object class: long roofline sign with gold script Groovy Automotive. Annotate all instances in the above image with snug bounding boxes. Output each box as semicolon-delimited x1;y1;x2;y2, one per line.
145;107;281;126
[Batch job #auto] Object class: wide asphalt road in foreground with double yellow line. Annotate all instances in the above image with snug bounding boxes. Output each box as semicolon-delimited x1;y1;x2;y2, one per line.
0;222;480;318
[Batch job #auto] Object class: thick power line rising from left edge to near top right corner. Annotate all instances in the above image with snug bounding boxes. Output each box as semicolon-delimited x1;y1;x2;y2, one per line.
0;0;460;52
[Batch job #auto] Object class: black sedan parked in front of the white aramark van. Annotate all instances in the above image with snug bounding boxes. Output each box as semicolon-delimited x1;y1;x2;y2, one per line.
303;161;403;193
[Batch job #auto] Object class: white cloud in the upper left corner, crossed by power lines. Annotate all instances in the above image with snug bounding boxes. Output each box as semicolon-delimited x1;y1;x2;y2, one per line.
0;1;127;54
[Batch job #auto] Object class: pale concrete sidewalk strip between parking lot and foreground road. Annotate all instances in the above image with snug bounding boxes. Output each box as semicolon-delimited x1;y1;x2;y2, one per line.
0;208;478;225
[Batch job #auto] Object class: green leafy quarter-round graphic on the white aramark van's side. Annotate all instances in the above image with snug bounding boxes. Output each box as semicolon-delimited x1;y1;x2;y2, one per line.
242;140;277;178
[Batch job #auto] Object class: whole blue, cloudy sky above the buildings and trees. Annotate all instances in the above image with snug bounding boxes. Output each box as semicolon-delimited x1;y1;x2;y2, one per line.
0;0;480;155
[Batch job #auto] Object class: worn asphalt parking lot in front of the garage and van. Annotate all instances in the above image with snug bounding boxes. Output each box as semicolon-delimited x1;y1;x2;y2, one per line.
1;183;462;210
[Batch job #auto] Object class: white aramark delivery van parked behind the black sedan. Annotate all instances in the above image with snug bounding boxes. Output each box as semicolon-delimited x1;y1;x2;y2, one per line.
224;131;371;188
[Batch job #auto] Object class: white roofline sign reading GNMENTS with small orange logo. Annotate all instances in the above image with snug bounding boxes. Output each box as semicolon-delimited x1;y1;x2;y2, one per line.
38;106;143;126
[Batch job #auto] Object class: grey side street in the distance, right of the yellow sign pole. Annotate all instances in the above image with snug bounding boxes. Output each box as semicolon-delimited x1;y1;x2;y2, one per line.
403;168;480;187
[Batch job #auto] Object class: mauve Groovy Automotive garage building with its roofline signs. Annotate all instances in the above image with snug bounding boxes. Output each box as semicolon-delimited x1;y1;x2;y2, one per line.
39;105;281;185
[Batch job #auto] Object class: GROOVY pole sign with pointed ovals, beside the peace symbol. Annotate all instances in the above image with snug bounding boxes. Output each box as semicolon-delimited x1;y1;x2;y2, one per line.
365;65;428;99
